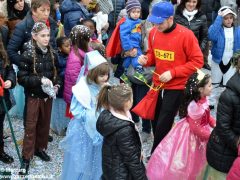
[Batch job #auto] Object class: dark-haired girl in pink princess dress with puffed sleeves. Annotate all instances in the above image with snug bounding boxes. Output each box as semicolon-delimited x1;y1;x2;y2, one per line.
147;70;216;180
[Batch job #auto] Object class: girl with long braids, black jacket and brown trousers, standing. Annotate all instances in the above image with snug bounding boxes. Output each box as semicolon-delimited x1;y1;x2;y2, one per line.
18;22;62;175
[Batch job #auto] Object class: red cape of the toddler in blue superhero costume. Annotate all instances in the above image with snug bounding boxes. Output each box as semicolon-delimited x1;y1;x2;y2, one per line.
106;18;126;57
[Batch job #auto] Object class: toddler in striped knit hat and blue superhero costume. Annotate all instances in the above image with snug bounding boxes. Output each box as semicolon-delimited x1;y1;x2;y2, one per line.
119;0;143;82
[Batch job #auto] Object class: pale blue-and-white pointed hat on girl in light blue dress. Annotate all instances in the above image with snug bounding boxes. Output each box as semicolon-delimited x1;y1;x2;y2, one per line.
84;50;107;70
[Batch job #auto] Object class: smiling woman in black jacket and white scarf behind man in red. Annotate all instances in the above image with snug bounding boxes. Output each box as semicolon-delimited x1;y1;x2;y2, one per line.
174;0;210;70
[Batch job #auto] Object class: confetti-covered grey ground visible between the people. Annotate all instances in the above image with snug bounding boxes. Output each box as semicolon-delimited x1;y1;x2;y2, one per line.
0;68;218;180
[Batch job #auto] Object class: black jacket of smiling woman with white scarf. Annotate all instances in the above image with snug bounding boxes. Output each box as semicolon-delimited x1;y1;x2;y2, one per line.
174;7;208;52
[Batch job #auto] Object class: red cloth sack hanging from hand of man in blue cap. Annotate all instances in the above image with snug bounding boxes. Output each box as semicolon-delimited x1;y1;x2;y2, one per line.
132;89;159;120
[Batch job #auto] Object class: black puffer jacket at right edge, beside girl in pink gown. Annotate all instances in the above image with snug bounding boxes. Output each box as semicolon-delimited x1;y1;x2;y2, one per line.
207;73;240;173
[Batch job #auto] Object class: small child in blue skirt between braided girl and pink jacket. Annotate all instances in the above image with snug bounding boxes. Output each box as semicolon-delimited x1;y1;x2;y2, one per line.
51;37;70;135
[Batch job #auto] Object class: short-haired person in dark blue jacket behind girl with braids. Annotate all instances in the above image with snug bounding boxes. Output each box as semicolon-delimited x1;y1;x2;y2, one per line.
7;0;58;65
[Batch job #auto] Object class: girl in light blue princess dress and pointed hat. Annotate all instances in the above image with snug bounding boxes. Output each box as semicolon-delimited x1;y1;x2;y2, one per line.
60;51;110;180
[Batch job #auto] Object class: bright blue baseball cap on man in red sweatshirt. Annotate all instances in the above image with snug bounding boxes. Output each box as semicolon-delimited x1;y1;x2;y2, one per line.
147;2;174;24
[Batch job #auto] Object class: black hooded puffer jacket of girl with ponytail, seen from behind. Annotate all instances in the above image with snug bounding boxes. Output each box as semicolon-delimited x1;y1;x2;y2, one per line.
97;110;147;180
